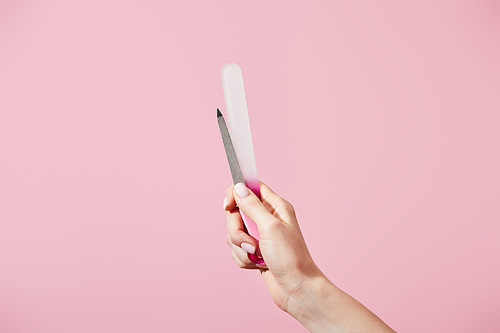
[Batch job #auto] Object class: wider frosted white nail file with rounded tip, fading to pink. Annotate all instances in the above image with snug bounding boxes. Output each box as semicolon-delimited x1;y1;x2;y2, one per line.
221;63;262;261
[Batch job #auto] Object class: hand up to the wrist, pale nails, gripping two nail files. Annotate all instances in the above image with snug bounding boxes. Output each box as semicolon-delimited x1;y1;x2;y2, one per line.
224;182;326;312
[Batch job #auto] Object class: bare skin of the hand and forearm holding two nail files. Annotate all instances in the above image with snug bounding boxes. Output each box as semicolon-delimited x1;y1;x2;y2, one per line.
224;182;394;332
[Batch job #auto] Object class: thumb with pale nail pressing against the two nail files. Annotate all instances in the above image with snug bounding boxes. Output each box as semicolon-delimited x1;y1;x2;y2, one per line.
234;183;279;231
